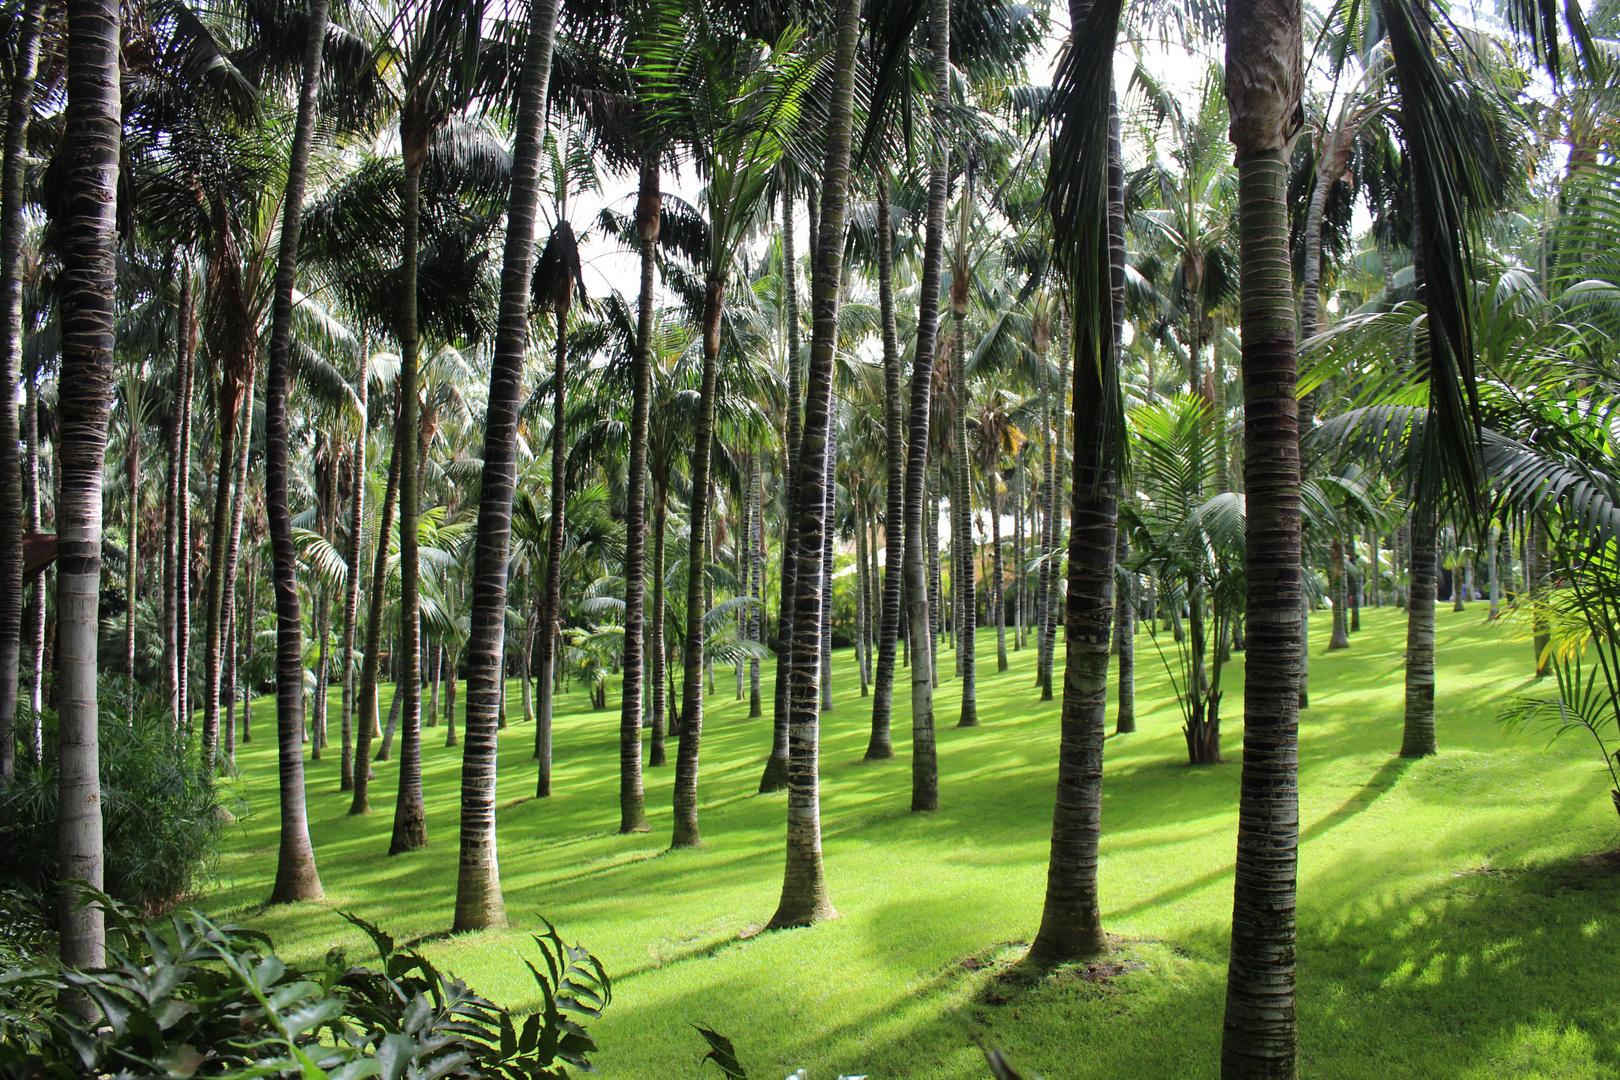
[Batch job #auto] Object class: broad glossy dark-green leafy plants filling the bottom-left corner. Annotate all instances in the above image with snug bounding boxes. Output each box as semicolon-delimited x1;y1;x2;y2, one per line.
0;897;611;1080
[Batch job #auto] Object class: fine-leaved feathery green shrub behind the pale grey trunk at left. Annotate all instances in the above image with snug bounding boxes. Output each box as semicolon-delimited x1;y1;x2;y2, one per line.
0;675;224;915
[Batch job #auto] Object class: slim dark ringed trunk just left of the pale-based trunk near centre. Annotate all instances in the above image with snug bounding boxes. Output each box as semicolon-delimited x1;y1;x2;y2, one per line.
865;181;906;761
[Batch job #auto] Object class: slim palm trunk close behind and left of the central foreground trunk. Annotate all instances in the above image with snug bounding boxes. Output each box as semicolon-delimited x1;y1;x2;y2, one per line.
760;183;815;793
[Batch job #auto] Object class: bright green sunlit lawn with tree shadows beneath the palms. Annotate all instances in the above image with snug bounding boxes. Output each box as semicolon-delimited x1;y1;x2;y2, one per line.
206;604;1620;1080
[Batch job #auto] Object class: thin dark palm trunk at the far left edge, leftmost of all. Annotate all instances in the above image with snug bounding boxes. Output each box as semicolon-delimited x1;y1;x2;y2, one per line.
0;0;43;792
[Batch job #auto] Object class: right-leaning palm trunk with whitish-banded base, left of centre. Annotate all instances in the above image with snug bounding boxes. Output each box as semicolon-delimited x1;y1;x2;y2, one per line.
450;0;560;933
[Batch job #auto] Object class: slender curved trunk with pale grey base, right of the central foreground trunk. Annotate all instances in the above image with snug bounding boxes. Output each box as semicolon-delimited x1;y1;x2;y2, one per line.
904;0;951;811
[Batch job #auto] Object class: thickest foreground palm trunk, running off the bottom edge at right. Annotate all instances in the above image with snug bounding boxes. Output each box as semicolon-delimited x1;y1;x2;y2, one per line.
1221;0;1304;1080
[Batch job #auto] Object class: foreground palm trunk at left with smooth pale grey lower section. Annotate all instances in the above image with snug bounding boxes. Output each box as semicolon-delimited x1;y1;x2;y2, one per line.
54;0;122;968
